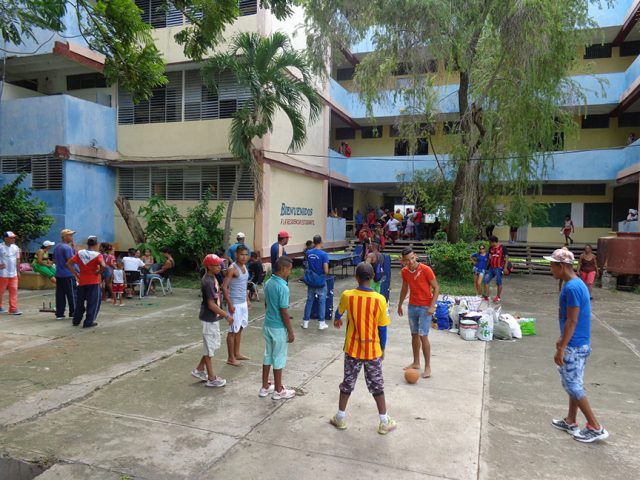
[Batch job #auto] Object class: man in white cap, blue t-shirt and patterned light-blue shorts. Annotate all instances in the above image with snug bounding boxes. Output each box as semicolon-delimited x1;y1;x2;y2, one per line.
544;248;609;443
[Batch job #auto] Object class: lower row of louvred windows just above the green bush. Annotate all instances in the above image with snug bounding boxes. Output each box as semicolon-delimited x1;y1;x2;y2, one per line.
118;165;255;200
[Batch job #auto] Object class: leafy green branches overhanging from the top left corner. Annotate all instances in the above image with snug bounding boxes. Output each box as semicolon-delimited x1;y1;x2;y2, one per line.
0;0;291;102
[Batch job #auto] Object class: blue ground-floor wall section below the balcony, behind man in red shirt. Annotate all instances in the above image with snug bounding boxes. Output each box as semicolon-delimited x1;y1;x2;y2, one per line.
64;160;116;244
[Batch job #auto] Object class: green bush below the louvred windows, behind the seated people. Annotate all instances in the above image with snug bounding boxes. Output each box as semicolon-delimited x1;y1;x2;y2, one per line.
138;195;224;271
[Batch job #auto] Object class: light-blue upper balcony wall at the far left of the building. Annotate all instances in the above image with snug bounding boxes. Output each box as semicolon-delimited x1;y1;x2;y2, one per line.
0;95;117;155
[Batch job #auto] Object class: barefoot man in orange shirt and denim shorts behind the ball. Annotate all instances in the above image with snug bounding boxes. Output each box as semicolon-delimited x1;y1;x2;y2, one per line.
398;247;440;378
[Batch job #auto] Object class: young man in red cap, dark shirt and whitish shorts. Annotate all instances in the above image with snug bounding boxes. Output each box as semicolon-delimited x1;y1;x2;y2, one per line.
191;253;233;388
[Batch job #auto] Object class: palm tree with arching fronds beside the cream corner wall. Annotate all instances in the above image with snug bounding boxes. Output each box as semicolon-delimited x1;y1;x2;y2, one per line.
202;32;322;249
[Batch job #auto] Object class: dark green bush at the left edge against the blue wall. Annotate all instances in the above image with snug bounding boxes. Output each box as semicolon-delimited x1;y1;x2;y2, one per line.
0;173;53;249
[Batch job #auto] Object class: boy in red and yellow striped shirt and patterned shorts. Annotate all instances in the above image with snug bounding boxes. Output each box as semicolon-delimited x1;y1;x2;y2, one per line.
330;262;396;435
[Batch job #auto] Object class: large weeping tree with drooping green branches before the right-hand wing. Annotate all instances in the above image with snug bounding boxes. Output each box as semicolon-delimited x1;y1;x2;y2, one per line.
302;0;608;242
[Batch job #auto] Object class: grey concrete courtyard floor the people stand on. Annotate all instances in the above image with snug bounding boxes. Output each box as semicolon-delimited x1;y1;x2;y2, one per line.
0;271;640;480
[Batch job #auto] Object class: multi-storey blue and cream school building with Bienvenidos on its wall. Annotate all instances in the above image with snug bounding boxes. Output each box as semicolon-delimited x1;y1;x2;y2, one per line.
0;0;640;256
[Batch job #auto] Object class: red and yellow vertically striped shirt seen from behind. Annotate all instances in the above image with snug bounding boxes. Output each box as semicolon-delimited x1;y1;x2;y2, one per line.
338;289;391;360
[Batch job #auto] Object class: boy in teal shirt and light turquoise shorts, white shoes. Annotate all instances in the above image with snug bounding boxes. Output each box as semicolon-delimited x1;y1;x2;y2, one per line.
258;257;296;400
